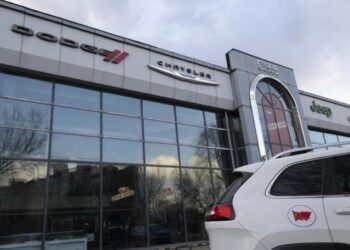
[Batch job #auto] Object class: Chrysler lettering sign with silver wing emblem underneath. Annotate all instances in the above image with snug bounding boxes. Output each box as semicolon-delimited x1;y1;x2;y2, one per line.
148;61;219;86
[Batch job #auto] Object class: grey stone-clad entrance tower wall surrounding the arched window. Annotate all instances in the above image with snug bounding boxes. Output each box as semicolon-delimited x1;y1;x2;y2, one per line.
226;50;310;163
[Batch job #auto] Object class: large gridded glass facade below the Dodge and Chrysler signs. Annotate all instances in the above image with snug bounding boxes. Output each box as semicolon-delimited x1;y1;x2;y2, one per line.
0;73;233;249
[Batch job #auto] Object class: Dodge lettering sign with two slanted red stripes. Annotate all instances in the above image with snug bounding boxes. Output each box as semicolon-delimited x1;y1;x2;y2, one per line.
12;24;129;64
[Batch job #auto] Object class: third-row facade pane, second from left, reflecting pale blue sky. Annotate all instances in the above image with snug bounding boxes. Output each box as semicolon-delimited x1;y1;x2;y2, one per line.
51;134;100;161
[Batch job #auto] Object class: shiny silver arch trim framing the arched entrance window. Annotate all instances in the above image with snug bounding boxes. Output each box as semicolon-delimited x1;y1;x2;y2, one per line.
249;74;307;160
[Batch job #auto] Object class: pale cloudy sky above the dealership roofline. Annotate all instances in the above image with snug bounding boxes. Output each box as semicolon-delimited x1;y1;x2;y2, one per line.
7;0;350;103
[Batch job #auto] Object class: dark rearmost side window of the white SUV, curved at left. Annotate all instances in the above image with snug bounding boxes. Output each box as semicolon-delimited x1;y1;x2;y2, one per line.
270;160;323;196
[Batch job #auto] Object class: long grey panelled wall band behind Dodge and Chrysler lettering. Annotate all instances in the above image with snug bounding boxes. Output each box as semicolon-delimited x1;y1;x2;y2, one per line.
0;1;233;110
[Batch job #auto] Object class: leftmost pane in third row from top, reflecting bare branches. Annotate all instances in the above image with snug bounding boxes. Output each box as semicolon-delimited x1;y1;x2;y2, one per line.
0;128;49;158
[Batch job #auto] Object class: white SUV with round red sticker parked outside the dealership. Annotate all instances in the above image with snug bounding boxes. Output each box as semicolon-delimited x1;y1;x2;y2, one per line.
205;147;350;250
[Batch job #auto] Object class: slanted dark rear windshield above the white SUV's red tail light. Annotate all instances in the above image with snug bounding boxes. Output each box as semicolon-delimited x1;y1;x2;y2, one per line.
216;172;253;204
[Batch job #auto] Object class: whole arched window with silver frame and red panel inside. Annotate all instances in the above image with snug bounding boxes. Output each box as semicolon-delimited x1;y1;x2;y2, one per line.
250;74;306;160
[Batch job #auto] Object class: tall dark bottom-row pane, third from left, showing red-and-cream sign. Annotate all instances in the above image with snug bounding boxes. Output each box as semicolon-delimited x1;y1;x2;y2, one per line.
103;165;147;249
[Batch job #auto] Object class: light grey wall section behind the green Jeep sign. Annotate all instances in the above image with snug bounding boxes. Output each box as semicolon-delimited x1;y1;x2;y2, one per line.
300;91;350;135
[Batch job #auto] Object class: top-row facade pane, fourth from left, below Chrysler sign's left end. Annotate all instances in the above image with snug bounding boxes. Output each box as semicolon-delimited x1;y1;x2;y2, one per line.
143;101;175;122
